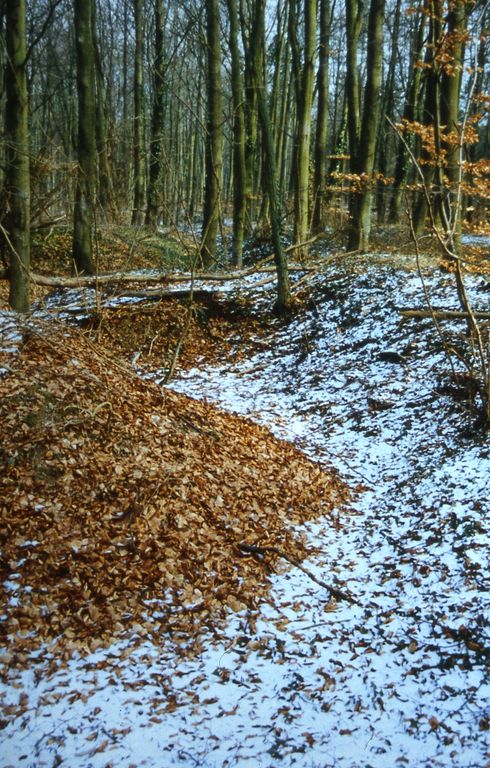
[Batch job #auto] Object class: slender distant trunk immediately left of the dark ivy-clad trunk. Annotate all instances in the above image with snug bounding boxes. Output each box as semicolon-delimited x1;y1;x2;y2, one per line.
131;0;145;226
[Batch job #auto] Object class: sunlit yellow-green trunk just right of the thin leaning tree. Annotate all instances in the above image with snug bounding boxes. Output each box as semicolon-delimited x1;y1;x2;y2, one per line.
294;0;317;251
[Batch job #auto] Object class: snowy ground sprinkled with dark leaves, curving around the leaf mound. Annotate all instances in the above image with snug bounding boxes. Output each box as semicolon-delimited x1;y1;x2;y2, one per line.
0;264;490;768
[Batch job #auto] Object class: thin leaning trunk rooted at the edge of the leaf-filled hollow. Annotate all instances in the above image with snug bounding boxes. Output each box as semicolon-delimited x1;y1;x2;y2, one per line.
250;0;291;313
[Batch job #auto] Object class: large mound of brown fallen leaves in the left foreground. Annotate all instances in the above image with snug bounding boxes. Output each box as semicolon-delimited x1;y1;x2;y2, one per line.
0;322;346;663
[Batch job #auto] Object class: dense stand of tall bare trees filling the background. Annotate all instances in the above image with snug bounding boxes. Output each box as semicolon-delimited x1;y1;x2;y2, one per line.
0;0;490;307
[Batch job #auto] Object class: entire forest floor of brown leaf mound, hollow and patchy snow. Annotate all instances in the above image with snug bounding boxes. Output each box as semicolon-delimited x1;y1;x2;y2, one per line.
0;230;490;768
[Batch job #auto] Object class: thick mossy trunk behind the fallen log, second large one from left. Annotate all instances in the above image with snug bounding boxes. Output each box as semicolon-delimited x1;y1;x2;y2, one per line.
73;0;97;275
